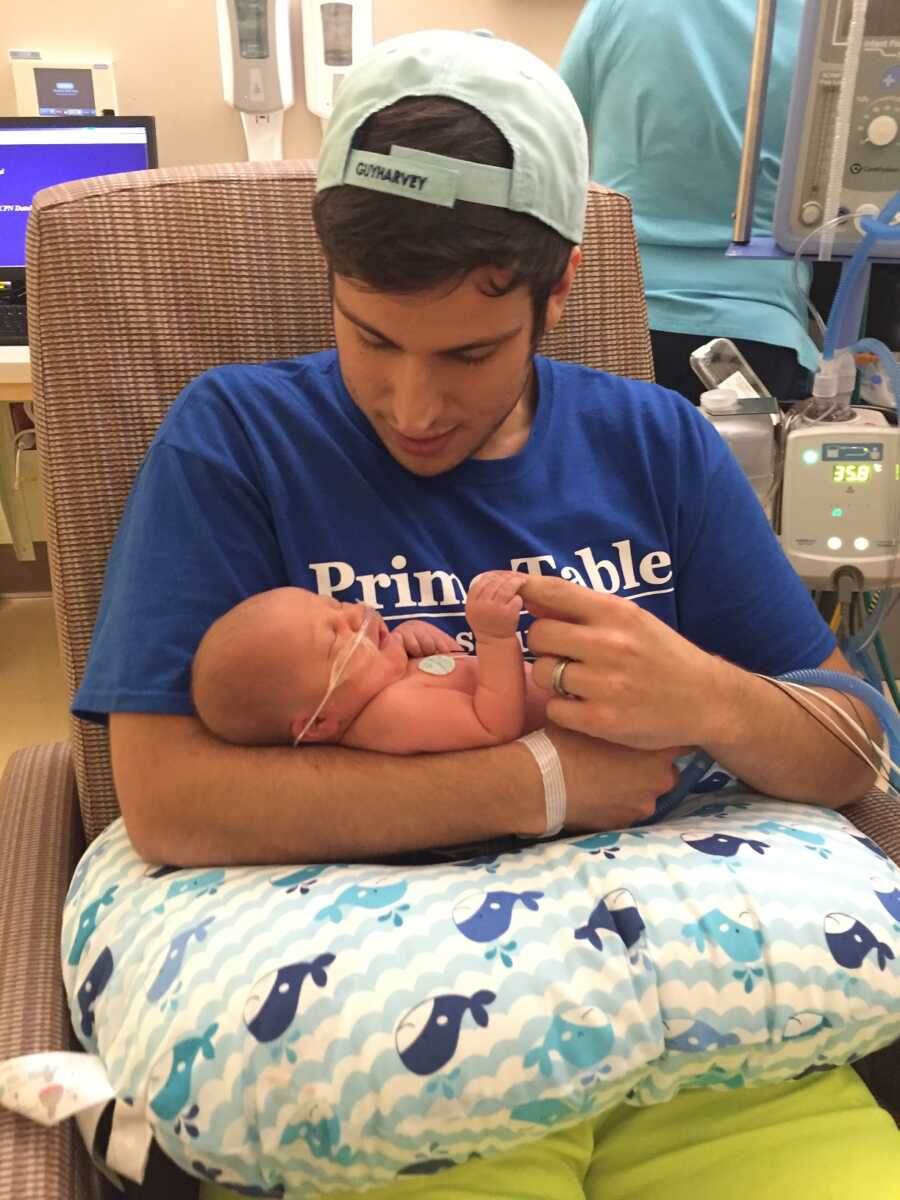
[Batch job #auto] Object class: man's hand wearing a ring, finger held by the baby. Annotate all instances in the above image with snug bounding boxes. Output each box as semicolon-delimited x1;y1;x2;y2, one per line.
522;576;739;750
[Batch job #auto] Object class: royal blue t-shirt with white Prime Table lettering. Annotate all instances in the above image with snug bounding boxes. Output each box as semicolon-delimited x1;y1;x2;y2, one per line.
73;350;835;721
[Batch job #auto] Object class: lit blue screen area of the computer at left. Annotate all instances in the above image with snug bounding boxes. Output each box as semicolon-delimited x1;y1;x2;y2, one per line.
0;127;148;266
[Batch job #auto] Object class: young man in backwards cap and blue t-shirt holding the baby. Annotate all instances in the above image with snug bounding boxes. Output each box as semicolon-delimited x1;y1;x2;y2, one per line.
74;32;898;1200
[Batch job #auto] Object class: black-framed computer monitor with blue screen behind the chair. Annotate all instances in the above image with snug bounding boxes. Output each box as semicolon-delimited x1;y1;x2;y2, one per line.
0;116;156;283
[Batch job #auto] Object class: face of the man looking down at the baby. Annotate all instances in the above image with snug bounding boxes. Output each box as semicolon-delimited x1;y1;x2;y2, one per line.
334;268;534;475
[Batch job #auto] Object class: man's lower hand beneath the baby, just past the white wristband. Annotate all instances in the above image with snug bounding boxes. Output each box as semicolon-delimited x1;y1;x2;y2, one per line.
517;725;685;836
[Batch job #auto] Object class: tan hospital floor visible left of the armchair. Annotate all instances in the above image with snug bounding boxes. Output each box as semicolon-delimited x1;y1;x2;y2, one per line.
0;596;68;774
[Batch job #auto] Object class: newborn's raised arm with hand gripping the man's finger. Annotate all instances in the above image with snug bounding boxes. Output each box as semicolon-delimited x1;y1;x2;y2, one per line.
466;571;527;742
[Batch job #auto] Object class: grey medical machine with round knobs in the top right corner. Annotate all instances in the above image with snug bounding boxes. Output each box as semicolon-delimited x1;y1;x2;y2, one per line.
777;0;900;258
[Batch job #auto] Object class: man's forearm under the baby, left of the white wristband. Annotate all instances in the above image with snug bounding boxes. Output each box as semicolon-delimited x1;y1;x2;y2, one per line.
110;714;544;866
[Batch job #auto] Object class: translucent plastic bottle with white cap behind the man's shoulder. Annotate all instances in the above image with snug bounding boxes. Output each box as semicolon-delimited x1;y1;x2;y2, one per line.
700;386;781;516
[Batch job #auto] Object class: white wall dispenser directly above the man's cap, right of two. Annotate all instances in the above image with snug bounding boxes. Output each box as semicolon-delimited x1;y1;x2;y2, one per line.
301;0;372;125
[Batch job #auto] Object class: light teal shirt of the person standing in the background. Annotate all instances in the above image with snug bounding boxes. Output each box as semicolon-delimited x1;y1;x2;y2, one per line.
559;0;818;370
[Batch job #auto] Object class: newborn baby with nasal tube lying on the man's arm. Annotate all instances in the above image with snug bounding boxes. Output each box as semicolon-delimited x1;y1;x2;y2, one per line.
192;571;550;754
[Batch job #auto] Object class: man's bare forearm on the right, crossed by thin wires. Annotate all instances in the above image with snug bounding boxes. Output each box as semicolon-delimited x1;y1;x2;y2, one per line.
702;660;881;808
